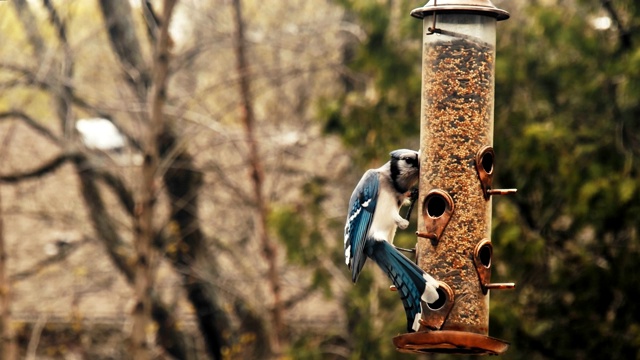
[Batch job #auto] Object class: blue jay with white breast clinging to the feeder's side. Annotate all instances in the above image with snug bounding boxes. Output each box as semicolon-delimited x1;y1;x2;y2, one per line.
344;149;439;332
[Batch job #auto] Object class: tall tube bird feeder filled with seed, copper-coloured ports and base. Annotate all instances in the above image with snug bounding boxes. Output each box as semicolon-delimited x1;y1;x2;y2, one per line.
393;0;515;355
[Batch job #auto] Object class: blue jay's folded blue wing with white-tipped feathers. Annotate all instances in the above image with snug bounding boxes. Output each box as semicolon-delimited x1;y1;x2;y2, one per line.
344;170;379;283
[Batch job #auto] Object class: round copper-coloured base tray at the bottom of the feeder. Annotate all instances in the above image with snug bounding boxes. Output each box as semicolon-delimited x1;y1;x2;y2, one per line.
393;330;509;355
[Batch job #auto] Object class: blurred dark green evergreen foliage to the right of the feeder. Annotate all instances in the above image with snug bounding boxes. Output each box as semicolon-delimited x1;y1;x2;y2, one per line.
492;1;640;359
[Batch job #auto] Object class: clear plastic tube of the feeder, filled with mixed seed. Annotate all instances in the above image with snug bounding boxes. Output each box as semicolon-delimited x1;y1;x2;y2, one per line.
417;12;496;334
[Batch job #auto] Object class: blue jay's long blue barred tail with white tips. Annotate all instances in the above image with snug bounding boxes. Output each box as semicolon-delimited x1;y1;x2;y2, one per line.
366;239;438;332
